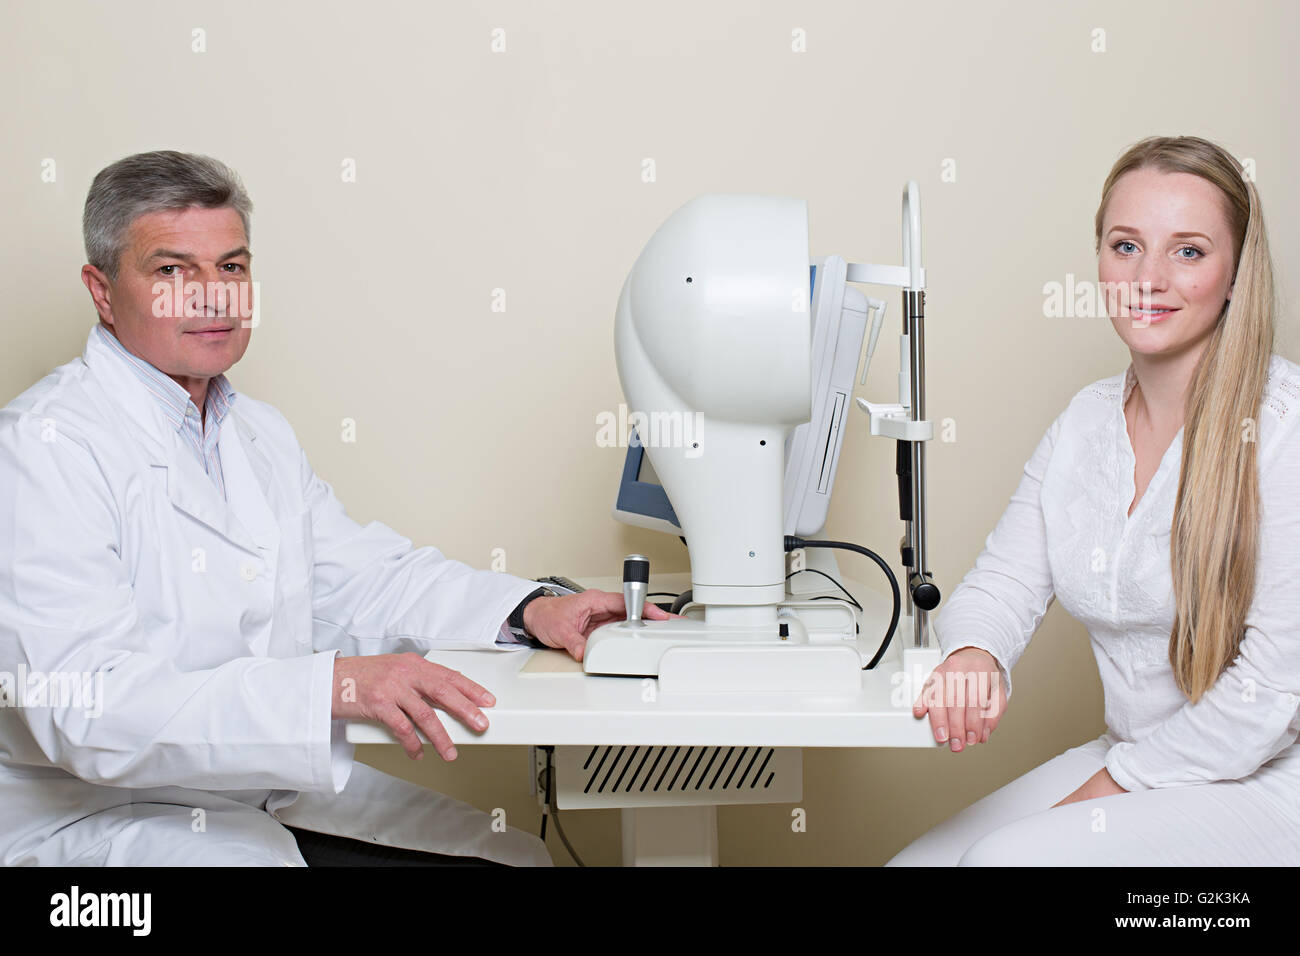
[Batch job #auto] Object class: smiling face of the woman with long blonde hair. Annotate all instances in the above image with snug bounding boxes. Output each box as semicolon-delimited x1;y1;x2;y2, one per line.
1097;168;1235;356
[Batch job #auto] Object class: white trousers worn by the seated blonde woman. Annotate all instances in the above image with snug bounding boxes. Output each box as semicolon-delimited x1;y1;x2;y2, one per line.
885;734;1300;866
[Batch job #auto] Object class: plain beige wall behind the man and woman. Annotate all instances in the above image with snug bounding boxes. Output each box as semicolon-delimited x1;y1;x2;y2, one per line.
0;0;1300;865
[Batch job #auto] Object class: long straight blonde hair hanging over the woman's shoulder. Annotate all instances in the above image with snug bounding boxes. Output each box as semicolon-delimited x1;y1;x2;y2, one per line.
1096;137;1275;702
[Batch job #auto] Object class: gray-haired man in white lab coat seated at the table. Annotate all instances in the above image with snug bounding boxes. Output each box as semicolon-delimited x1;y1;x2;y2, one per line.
0;151;664;865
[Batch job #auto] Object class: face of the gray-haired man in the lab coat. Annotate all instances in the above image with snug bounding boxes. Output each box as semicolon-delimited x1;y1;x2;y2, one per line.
82;207;252;388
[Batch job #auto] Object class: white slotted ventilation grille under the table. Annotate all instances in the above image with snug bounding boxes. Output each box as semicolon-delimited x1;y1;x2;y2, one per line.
581;747;776;796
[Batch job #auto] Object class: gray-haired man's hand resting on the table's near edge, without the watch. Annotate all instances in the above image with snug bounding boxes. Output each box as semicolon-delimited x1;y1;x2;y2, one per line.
330;650;493;760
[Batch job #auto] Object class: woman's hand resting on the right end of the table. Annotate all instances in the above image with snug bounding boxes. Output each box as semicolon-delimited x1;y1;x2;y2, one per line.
911;648;1006;753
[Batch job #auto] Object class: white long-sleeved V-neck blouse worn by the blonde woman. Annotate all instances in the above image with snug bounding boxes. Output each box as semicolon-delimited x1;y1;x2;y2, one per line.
935;355;1300;793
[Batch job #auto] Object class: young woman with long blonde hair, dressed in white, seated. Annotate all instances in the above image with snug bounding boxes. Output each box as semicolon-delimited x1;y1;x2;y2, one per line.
888;137;1300;866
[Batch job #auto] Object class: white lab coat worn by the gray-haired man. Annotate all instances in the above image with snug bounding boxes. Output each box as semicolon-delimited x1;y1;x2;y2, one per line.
0;327;551;865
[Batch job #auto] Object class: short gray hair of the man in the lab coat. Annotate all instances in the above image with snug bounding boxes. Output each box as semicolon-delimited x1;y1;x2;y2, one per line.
82;150;252;280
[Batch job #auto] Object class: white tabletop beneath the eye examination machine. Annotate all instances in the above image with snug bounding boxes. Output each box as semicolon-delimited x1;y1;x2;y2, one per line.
347;574;939;747
